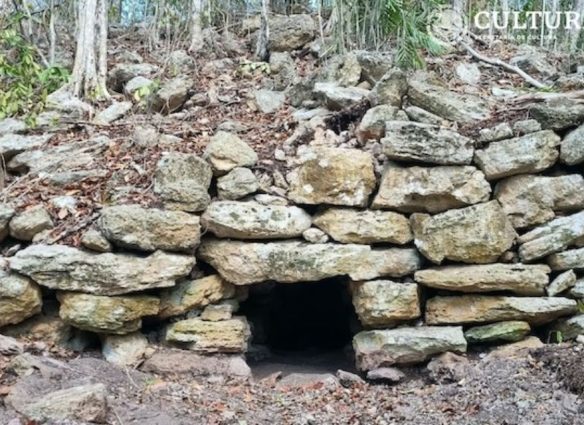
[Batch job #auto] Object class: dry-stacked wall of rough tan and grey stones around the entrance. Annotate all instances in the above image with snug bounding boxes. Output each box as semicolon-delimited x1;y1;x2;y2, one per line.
0;63;584;370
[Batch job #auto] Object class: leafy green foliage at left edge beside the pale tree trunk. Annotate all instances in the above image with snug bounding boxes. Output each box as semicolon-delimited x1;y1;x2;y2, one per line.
0;27;69;123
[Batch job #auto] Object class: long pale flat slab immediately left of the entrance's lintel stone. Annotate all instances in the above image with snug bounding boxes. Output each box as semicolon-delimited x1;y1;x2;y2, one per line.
10;245;195;295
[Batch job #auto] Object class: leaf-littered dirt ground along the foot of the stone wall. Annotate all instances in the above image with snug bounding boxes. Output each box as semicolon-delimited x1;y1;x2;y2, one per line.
0;345;584;425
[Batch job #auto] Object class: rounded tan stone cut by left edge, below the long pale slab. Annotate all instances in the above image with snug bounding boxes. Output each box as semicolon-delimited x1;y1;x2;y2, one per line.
0;270;43;327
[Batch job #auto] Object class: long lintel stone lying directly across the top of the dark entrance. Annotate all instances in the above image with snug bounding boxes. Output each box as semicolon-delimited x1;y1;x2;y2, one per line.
199;240;420;285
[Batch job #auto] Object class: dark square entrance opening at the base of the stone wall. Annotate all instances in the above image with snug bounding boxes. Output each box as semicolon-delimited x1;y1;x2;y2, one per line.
242;279;358;369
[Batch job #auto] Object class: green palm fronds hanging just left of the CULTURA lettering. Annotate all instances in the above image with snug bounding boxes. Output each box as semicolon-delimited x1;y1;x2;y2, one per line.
384;0;443;68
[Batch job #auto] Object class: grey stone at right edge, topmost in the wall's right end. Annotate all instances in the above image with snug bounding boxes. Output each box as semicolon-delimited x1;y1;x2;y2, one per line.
529;99;584;130
